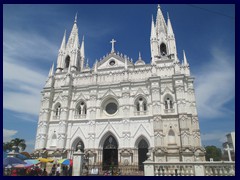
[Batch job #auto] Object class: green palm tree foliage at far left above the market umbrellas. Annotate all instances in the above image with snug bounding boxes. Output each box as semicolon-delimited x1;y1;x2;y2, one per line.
3;138;27;152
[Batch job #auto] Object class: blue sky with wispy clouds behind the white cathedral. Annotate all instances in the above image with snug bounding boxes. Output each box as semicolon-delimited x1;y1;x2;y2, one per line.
3;4;235;152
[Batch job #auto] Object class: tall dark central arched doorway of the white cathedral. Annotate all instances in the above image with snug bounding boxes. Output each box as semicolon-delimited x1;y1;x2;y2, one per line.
102;135;118;170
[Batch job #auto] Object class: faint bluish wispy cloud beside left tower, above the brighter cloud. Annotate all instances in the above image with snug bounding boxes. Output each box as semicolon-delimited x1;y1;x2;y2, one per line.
3;29;59;61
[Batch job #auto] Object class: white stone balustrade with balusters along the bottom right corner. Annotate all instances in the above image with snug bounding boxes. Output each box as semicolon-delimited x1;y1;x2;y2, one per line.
144;160;235;176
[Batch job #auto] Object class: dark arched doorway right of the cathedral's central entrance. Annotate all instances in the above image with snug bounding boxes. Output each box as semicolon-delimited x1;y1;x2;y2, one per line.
138;139;148;171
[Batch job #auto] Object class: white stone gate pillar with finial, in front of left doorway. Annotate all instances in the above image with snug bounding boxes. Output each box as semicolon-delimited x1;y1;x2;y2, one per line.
72;145;84;176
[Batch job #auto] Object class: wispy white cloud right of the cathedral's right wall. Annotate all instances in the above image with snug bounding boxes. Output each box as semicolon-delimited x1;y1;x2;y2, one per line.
195;48;235;118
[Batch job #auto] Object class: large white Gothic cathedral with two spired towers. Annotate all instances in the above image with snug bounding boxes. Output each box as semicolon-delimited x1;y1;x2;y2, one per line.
35;5;205;167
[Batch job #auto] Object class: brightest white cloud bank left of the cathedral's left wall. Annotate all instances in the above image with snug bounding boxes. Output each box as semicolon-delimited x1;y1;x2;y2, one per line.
3;61;46;115
